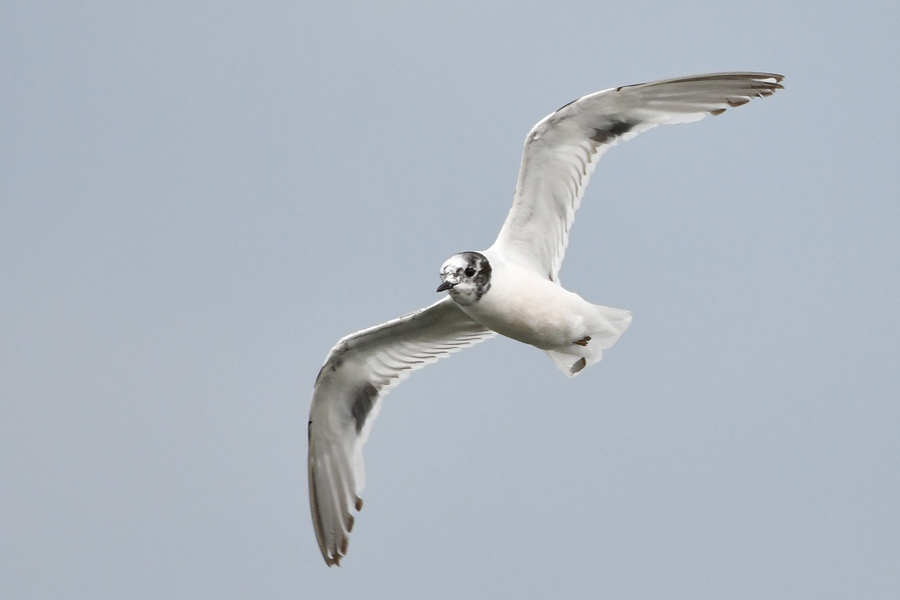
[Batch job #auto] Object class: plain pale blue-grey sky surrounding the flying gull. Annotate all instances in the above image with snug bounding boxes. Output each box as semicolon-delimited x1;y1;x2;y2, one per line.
0;0;900;599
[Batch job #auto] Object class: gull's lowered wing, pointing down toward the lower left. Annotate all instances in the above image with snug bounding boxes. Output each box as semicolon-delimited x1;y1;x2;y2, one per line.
308;296;496;566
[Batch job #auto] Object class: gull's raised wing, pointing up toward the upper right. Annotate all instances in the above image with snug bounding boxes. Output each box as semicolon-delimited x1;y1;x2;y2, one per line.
492;73;783;282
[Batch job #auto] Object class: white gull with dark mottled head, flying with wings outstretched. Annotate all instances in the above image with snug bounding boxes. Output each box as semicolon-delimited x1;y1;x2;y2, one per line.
308;72;784;566
